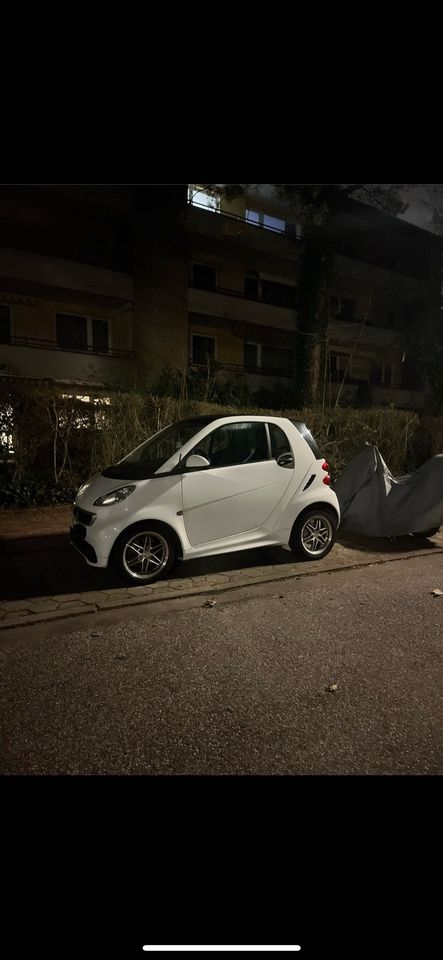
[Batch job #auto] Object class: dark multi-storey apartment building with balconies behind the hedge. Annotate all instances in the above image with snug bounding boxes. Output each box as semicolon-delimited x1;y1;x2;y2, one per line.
0;185;442;409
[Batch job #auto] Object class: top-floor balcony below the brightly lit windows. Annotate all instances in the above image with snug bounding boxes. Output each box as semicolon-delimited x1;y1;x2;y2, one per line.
187;203;303;260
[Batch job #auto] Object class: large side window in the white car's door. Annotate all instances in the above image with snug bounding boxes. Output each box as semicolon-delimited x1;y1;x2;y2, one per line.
192;423;269;467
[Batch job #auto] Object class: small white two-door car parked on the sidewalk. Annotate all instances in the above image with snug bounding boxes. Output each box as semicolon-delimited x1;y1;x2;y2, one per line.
71;416;340;583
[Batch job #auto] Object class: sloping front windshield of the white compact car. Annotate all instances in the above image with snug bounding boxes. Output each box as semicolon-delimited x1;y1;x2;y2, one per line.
103;417;212;480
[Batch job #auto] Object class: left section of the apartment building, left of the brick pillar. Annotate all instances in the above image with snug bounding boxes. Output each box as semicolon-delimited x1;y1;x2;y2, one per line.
0;185;134;386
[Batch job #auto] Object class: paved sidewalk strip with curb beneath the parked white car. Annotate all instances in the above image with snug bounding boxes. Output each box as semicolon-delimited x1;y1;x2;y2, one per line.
0;506;443;629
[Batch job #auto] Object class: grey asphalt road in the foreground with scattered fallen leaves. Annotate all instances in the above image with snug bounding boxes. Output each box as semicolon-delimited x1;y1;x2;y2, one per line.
0;554;443;775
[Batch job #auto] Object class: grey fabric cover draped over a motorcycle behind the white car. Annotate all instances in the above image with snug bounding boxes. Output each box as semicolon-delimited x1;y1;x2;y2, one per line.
333;445;443;537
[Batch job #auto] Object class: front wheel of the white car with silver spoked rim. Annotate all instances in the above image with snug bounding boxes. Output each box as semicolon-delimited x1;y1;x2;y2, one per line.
112;520;177;586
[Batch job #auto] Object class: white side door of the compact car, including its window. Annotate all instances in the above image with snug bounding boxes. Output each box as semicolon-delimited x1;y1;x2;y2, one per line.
182;421;293;546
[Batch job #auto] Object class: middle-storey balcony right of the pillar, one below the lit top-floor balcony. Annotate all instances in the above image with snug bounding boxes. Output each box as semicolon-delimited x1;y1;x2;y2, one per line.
188;284;297;330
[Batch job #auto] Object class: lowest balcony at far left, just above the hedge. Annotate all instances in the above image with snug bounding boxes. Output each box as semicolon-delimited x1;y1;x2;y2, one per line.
0;337;134;384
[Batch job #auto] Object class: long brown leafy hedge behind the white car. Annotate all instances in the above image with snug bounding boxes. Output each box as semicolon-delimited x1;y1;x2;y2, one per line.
0;378;443;506
